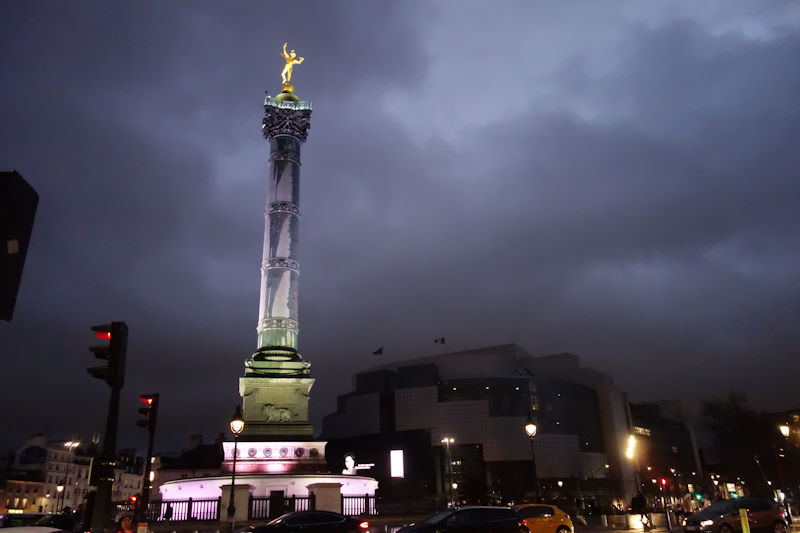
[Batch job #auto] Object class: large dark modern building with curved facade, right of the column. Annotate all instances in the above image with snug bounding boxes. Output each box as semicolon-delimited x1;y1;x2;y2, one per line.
322;344;634;503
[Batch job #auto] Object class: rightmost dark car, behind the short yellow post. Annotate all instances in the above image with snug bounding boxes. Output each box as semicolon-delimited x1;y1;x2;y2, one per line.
683;498;786;533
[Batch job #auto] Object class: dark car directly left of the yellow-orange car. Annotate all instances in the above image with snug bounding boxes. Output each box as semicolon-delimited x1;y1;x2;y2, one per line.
397;506;530;533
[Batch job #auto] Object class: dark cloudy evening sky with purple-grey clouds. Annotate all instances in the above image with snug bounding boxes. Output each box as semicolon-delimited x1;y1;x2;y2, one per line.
0;0;800;451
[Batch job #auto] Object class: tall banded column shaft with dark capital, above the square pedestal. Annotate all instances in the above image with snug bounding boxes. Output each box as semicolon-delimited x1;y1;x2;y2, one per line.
258;93;311;354
